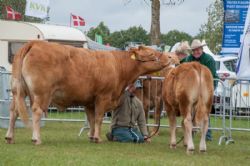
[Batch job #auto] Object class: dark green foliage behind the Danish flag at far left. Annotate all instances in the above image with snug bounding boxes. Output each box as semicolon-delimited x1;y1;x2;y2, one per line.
0;0;49;22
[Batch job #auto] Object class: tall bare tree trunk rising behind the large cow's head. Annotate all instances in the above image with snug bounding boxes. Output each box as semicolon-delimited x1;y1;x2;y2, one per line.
150;0;160;45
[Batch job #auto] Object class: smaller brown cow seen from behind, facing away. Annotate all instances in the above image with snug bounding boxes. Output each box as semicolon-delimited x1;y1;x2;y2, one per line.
163;62;214;153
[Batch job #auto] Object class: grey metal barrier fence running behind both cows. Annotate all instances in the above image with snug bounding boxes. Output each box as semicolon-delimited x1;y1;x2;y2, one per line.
0;70;250;145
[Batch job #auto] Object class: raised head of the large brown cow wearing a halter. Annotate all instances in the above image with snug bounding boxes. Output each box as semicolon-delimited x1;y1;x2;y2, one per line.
129;46;171;73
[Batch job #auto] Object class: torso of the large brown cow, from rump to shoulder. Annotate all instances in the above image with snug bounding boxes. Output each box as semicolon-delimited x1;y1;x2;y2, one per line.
22;41;117;106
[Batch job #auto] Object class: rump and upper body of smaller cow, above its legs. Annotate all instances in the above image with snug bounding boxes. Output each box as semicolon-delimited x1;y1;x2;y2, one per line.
163;62;213;110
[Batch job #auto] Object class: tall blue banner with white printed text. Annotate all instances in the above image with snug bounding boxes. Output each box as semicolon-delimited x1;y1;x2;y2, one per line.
221;0;250;54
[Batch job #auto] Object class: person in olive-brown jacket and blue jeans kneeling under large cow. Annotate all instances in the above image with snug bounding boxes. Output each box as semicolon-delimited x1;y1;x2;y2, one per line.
106;84;151;143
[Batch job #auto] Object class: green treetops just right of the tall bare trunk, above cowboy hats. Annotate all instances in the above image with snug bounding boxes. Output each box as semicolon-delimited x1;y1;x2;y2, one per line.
161;30;193;46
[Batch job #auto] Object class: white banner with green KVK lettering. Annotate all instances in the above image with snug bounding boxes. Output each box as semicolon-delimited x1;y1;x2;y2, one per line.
25;0;49;19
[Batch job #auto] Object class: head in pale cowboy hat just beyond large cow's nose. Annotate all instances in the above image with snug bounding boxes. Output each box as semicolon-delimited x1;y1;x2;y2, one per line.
175;41;191;63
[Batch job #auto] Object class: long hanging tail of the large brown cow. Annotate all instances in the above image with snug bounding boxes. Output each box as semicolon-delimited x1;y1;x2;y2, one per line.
12;42;33;126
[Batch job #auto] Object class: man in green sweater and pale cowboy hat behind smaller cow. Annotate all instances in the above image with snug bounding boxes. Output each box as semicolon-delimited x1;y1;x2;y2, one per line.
183;39;219;141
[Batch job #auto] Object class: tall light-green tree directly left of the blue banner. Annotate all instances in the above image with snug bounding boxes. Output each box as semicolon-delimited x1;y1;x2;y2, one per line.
196;0;223;53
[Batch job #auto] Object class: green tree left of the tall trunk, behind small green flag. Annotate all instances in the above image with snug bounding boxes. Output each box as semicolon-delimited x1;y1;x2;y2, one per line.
87;22;110;44
